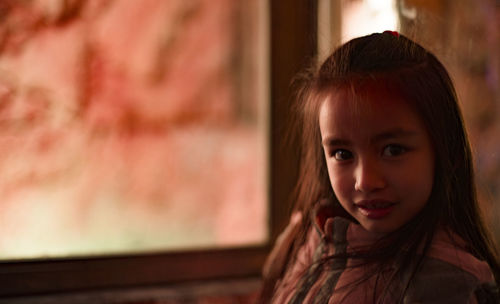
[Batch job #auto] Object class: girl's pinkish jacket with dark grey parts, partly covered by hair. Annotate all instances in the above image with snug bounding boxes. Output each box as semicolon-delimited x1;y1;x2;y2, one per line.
264;202;500;304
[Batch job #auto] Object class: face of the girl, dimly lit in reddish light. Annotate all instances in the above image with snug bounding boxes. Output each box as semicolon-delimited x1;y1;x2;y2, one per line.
319;89;434;234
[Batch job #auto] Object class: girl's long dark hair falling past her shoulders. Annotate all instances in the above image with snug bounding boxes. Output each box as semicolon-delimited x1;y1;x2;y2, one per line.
264;33;500;300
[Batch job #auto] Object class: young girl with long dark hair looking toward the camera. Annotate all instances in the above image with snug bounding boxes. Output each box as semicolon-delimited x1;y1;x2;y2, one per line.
262;32;500;303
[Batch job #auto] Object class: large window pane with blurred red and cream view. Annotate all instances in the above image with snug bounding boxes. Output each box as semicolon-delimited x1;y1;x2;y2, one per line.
0;0;267;259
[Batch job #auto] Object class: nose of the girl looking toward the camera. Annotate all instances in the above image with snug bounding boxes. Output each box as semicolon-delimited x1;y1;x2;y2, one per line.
354;161;386;193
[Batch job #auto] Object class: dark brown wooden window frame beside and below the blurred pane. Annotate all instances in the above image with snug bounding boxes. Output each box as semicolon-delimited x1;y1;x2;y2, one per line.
0;0;317;298
